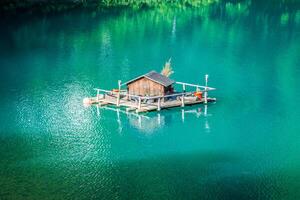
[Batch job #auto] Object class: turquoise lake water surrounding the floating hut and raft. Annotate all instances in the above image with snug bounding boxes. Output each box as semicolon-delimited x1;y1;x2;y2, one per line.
0;1;300;200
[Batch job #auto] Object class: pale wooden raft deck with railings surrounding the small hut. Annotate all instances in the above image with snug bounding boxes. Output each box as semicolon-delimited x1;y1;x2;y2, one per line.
84;75;216;113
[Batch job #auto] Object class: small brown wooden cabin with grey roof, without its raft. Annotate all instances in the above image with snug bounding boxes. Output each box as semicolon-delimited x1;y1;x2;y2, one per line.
126;71;175;96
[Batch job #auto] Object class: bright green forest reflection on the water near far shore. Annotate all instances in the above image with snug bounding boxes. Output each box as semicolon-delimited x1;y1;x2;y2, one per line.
1;0;300;53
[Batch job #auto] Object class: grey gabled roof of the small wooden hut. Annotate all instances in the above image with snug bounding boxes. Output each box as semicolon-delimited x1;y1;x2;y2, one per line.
125;71;175;87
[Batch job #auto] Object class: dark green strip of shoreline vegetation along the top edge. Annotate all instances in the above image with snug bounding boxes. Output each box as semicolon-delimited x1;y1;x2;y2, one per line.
0;0;300;15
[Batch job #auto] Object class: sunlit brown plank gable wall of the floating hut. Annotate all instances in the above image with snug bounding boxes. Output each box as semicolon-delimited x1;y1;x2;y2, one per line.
128;77;164;96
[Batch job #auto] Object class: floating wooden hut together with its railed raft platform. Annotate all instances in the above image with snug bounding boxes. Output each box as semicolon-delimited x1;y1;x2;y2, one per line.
84;71;216;112
